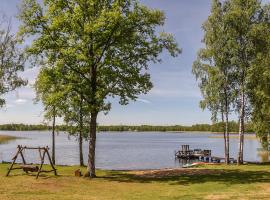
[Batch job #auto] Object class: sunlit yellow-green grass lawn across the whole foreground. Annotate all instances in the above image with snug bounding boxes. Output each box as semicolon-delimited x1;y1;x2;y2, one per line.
0;164;270;200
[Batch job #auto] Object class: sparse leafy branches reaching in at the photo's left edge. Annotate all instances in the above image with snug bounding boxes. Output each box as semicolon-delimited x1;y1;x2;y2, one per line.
0;16;27;107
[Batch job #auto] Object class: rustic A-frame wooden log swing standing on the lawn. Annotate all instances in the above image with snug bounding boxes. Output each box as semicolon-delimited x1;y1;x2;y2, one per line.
6;145;57;178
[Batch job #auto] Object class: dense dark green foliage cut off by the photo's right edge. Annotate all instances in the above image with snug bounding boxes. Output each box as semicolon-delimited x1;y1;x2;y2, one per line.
248;4;270;148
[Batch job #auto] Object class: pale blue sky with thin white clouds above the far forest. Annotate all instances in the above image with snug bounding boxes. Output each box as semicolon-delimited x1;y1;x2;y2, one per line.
0;0;269;125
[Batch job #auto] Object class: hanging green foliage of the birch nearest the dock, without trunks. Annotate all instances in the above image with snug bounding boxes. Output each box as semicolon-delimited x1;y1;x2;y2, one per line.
192;0;236;121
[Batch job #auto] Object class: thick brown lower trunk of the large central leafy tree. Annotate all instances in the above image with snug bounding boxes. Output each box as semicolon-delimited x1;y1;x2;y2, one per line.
85;112;98;178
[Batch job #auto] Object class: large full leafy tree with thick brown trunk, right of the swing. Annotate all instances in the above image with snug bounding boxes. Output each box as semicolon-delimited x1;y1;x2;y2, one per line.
19;0;181;177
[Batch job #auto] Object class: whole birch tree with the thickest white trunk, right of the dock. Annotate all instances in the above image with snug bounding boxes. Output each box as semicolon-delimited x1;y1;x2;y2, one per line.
224;0;262;164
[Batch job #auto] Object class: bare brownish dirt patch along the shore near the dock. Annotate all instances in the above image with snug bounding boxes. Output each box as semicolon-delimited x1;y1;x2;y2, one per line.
130;168;224;178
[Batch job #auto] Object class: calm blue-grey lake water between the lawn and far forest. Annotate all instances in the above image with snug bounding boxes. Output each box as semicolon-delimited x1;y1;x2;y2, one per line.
0;131;265;170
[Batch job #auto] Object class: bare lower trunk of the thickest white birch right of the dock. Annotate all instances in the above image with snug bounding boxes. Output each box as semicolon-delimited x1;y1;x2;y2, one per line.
237;88;245;165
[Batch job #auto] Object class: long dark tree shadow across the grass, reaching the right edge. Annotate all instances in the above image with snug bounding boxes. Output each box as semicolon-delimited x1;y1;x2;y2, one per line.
99;169;270;185
